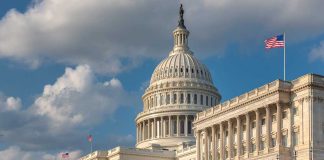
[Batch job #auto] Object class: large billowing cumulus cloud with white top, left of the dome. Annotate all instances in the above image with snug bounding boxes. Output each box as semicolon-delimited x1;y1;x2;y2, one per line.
0;65;135;156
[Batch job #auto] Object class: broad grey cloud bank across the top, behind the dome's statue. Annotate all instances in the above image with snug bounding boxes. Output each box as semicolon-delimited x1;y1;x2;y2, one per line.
0;0;324;73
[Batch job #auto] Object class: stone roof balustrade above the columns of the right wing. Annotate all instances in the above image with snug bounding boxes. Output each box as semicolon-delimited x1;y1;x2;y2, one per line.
197;80;292;120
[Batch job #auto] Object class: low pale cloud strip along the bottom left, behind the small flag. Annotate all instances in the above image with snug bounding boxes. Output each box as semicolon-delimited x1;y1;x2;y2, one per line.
0;146;81;160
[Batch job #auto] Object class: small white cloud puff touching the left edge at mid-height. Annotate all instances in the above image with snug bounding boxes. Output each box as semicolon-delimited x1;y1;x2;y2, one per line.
0;95;21;112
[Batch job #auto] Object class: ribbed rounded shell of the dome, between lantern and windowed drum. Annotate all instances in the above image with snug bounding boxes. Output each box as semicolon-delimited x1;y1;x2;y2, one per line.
150;50;213;85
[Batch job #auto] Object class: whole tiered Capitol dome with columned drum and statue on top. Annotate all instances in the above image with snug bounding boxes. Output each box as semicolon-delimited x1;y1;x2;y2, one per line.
135;6;221;150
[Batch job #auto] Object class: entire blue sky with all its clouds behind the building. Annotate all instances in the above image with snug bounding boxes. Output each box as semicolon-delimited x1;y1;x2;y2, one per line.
0;0;324;159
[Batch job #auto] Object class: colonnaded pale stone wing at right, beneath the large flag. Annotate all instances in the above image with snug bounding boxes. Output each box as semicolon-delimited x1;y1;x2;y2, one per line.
194;74;324;160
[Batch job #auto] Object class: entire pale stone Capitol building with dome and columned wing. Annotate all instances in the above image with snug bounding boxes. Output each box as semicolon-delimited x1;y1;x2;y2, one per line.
81;6;324;160
